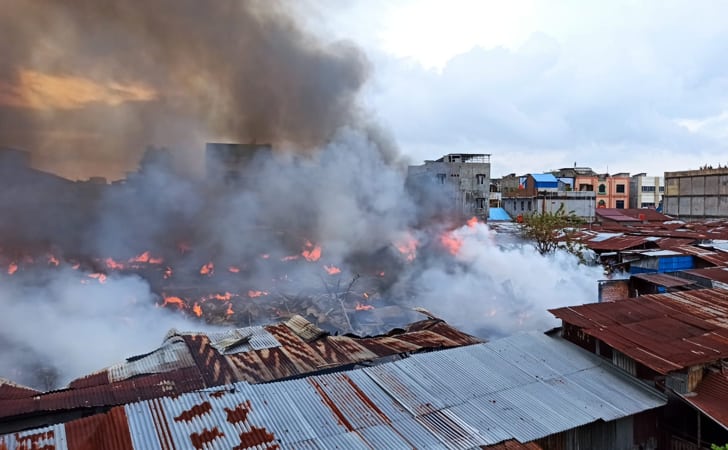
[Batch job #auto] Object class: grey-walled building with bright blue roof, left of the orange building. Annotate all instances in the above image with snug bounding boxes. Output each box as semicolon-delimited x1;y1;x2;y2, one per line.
501;173;596;222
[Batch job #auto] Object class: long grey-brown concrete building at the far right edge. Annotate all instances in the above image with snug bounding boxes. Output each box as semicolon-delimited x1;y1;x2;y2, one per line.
663;167;728;220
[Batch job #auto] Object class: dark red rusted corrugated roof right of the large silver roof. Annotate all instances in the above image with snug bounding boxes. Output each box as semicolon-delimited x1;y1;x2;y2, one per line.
550;289;728;374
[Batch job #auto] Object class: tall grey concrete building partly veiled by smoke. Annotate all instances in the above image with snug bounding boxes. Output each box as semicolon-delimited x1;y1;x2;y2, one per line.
407;153;490;220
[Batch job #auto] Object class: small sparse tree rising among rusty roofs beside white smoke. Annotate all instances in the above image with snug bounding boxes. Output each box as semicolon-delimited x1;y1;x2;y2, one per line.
521;203;584;262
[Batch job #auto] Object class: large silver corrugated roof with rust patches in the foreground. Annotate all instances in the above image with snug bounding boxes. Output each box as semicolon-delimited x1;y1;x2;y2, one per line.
0;333;666;450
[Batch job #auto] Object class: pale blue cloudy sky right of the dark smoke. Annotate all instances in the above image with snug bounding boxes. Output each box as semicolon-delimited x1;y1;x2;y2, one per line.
299;0;728;177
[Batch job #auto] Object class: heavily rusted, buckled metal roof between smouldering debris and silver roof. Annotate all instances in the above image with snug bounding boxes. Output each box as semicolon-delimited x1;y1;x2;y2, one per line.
0;316;481;426
